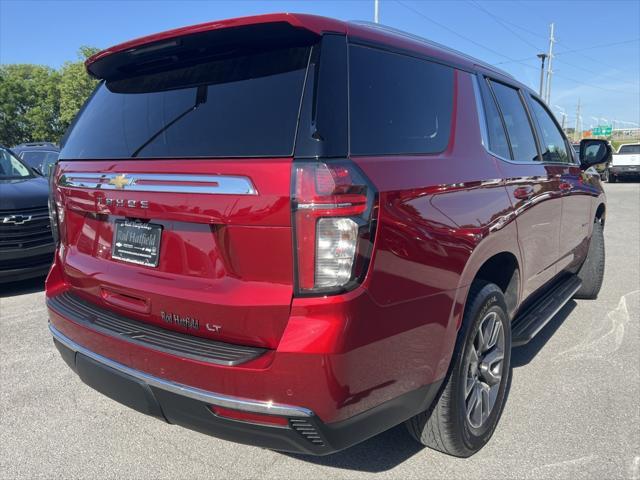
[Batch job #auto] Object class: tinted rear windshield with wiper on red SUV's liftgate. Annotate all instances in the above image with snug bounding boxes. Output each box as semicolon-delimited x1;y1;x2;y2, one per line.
60;46;310;159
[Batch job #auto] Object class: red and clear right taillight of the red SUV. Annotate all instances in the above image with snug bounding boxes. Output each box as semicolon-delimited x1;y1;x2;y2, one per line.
292;160;376;294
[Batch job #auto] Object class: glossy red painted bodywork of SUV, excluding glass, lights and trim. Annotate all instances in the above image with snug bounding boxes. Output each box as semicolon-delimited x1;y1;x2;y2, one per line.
47;14;603;430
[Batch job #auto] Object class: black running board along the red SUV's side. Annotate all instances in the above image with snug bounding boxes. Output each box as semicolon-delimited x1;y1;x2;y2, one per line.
511;275;582;347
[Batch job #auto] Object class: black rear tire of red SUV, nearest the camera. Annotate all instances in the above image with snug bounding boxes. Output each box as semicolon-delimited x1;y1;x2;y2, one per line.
406;281;511;457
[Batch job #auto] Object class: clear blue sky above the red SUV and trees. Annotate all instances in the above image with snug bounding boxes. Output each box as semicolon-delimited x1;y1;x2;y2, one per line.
0;0;640;129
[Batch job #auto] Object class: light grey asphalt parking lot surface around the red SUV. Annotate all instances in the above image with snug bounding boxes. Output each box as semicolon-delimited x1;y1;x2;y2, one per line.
0;183;640;479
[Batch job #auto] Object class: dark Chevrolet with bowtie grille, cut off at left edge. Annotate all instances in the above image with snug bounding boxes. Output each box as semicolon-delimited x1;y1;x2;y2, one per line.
0;146;55;283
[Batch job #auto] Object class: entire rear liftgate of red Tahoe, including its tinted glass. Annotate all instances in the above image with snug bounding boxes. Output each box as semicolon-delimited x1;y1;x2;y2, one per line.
57;35;311;348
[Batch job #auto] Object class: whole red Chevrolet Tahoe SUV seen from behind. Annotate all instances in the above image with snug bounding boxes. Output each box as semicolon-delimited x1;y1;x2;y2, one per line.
47;14;611;457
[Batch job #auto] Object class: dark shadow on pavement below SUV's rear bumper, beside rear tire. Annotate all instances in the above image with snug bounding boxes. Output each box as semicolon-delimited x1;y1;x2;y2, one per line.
282;424;425;473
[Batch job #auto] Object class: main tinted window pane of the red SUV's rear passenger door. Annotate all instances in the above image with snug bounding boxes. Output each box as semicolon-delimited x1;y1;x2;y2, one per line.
491;82;539;162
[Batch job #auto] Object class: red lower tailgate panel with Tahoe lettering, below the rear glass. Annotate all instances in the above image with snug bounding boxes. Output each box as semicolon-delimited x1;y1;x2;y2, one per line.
58;158;293;348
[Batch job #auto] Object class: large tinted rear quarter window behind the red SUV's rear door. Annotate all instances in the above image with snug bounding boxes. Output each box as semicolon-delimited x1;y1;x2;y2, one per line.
349;45;453;155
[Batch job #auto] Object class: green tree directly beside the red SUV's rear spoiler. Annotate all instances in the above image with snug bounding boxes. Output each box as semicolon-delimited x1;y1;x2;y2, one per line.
60;46;99;130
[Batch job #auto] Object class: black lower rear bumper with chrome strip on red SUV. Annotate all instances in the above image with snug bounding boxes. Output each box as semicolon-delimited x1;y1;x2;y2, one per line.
49;325;440;455
